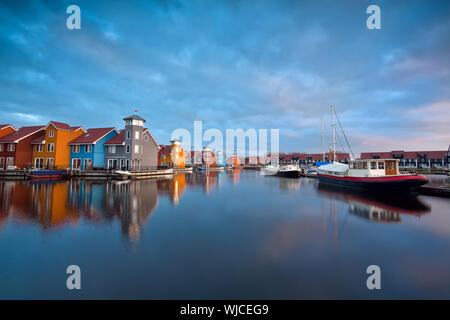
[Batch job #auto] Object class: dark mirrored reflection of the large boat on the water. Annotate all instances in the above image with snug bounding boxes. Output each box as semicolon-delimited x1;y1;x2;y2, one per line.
318;185;431;223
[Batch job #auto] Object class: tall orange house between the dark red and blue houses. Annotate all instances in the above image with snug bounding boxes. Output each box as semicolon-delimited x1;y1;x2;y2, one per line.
31;121;86;169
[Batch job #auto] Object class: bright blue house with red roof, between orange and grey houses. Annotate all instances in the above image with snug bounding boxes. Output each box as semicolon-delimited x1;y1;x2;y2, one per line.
69;127;119;170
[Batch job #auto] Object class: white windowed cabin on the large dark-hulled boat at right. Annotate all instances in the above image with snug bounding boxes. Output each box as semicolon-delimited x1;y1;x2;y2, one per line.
348;159;400;177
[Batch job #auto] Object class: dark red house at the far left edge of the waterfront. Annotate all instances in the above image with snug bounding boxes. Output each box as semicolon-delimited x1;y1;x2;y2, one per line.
0;126;45;169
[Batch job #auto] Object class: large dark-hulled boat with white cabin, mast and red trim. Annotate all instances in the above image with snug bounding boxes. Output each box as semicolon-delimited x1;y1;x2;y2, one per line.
317;106;428;192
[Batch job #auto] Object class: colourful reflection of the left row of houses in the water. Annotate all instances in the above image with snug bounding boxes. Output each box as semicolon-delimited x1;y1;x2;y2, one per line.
0;174;192;241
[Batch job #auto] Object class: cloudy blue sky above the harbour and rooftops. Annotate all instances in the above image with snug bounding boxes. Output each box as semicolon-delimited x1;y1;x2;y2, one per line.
0;0;450;154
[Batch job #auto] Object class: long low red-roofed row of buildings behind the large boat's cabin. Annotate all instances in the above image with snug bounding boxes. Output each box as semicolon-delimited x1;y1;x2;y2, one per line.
361;150;450;168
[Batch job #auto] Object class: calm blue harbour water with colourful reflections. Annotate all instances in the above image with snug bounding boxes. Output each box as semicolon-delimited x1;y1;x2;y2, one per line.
0;171;450;299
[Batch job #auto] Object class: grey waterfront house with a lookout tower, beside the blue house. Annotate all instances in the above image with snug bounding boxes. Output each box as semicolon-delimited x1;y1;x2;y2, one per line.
105;114;159;170
